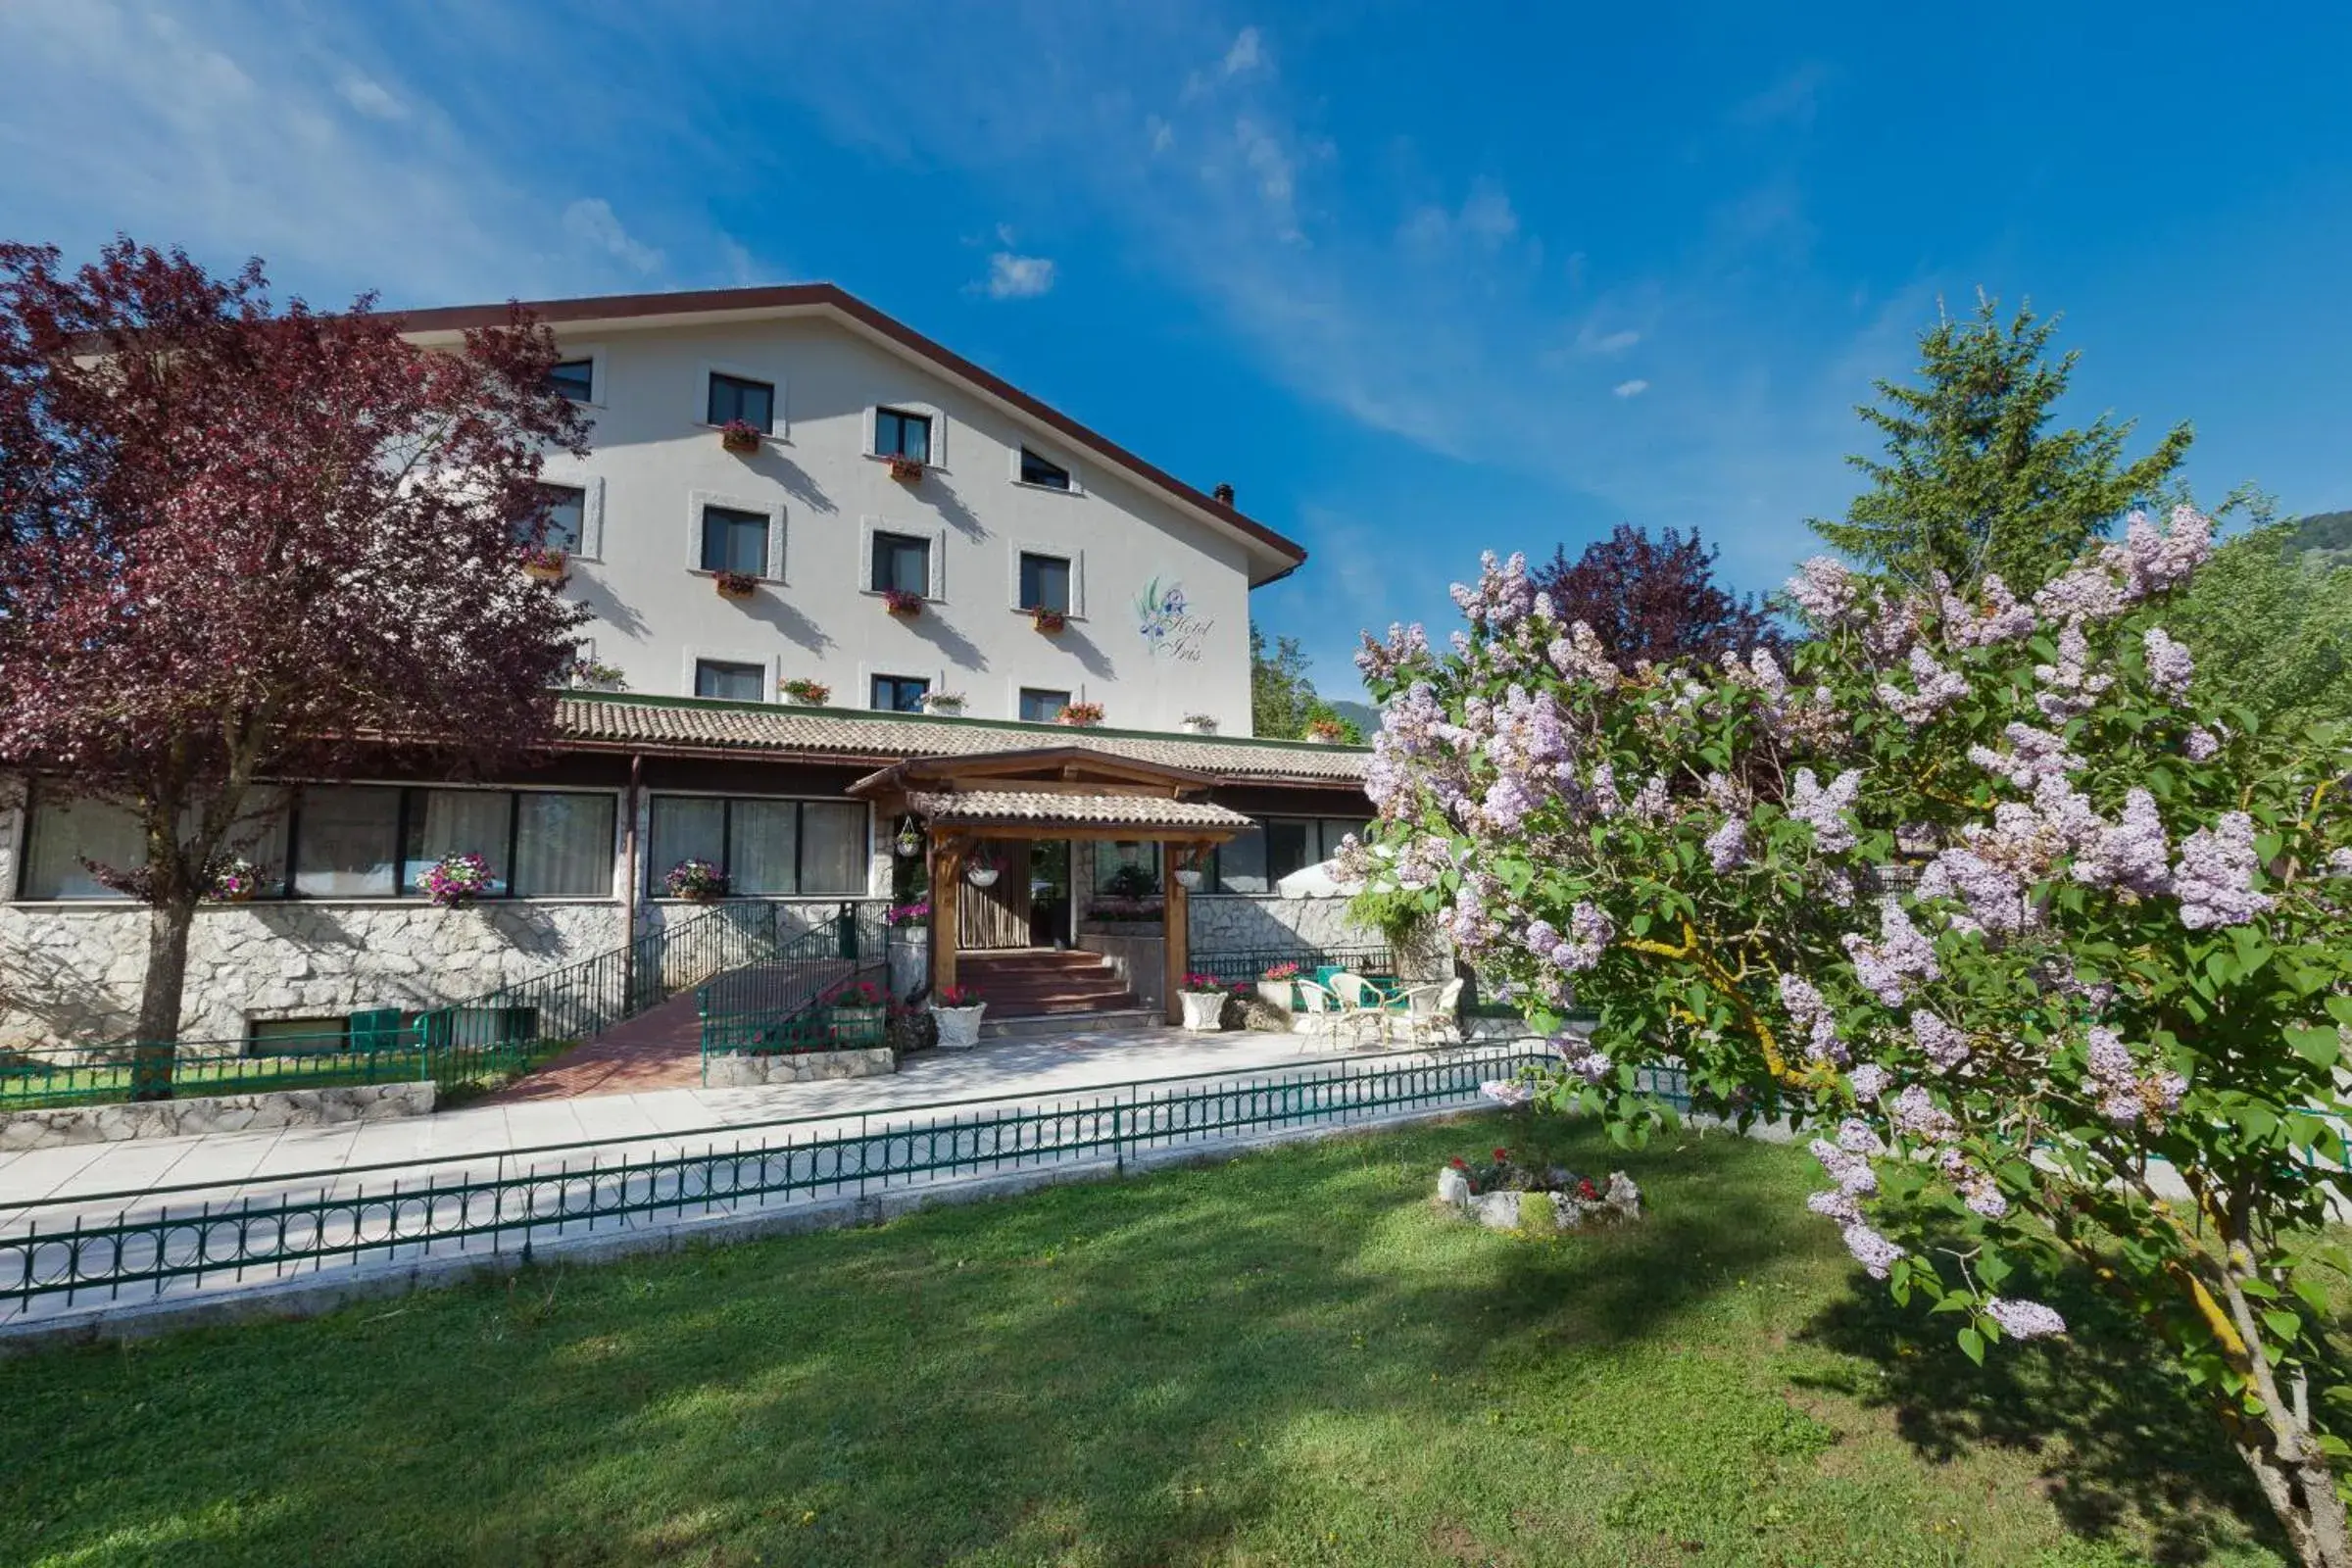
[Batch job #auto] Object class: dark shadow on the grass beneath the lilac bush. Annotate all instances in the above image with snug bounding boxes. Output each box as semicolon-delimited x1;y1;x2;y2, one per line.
1799;1272;2293;1563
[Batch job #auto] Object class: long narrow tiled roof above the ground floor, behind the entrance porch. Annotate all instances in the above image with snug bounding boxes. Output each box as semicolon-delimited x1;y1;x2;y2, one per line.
555;694;1369;788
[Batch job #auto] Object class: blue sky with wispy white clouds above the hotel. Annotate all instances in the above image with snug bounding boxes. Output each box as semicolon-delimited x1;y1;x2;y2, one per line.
0;0;2352;694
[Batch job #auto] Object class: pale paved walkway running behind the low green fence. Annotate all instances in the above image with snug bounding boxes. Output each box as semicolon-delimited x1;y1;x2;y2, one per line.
0;1027;1392;1230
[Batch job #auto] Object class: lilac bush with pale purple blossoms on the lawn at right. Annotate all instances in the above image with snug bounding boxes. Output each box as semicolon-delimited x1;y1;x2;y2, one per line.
1350;508;2352;1566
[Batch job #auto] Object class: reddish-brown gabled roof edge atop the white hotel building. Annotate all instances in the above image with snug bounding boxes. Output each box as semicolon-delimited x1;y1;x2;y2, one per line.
400;282;1307;585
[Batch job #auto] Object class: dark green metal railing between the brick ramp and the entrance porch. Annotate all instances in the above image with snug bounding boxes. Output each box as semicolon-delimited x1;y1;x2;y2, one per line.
696;906;889;1084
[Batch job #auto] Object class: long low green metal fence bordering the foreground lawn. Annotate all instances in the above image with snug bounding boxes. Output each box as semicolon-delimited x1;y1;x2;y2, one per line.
0;1042;1687;1316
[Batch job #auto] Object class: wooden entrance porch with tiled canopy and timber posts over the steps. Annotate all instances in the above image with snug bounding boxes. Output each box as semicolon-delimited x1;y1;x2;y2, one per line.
849;745;1251;1022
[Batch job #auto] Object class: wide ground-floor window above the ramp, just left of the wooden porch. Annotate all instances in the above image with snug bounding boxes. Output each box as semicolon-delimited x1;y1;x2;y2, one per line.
645;795;865;898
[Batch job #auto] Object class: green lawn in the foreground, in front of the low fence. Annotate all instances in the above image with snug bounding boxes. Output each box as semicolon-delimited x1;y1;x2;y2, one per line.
0;1116;2279;1568
